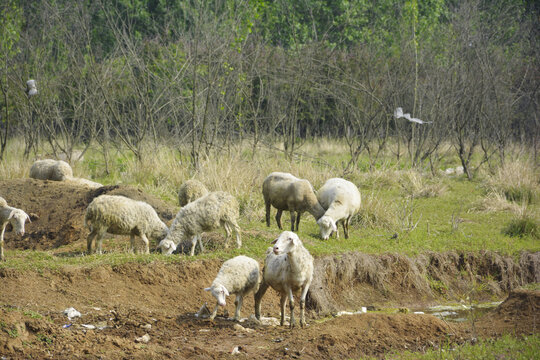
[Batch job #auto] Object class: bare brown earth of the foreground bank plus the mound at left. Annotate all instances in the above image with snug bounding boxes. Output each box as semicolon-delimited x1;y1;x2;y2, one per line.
0;179;540;359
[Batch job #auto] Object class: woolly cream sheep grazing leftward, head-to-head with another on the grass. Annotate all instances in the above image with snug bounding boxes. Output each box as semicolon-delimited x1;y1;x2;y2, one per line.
158;191;242;256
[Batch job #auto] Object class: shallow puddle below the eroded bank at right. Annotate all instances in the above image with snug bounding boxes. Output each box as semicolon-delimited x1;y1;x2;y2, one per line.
415;301;502;322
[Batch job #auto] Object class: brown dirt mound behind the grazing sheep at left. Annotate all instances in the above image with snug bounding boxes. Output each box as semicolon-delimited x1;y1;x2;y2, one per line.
0;179;177;250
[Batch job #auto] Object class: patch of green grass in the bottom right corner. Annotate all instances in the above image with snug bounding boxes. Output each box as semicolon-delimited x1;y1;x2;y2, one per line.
386;334;540;360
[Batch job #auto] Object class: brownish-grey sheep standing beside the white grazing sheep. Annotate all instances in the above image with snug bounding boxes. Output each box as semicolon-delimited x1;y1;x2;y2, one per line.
262;172;324;231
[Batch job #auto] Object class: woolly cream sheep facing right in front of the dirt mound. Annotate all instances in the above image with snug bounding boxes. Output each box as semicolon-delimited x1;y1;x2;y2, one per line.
85;195;168;254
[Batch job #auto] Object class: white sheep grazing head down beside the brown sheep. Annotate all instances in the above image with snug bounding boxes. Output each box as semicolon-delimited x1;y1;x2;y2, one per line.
317;178;361;240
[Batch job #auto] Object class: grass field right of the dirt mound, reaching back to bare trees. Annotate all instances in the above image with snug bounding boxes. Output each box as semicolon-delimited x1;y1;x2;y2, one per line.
0;139;540;262
